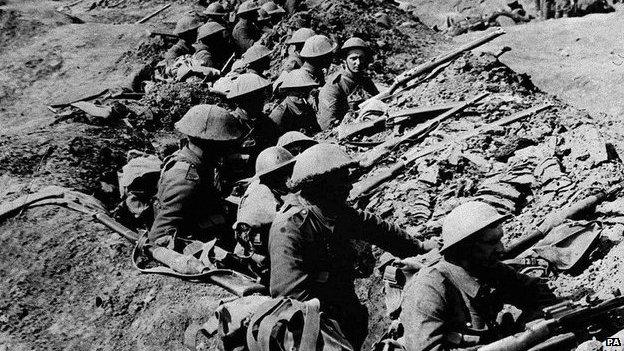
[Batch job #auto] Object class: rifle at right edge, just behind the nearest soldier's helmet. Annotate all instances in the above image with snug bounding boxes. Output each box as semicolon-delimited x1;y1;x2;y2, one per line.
503;185;623;258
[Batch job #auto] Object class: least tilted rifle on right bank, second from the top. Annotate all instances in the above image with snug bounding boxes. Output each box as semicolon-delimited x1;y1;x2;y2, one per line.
338;103;457;140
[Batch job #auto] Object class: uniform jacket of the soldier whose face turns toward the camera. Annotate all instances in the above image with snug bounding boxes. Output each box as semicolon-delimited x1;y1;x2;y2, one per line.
317;68;379;130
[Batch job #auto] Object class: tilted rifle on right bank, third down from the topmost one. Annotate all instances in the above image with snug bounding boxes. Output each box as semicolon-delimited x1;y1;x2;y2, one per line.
359;93;488;168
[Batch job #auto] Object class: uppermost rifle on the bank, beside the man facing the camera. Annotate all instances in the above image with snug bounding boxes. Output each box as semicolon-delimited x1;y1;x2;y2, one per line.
371;30;505;100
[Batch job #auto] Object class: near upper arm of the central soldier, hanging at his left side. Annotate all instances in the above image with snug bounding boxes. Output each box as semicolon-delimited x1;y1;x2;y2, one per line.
269;216;311;300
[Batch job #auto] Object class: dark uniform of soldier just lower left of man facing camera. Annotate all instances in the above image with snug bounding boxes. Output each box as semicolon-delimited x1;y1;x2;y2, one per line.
269;96;321;136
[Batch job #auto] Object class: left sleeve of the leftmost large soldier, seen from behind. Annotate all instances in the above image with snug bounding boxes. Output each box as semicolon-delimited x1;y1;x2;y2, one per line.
149;165;197;242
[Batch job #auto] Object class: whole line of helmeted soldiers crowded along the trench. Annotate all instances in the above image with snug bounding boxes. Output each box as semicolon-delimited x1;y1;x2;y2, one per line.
148;0;564;350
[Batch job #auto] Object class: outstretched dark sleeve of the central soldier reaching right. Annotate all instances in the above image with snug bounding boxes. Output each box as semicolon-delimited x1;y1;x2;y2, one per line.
340;207;425;258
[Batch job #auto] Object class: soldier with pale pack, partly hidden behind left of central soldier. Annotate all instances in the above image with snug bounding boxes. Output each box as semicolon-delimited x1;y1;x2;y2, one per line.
234;146;294;284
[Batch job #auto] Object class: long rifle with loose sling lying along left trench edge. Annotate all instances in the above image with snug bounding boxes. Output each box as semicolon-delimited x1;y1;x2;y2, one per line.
5;186;266;296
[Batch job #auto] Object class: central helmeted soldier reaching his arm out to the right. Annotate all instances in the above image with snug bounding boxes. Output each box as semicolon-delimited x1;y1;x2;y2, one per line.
269;144;438;348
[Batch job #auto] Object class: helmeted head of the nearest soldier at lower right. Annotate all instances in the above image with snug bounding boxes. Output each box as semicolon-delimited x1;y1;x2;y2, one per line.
440;201;509;268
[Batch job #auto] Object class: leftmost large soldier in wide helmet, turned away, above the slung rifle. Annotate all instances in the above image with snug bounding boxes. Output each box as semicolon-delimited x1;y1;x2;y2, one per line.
149;105;245;250
